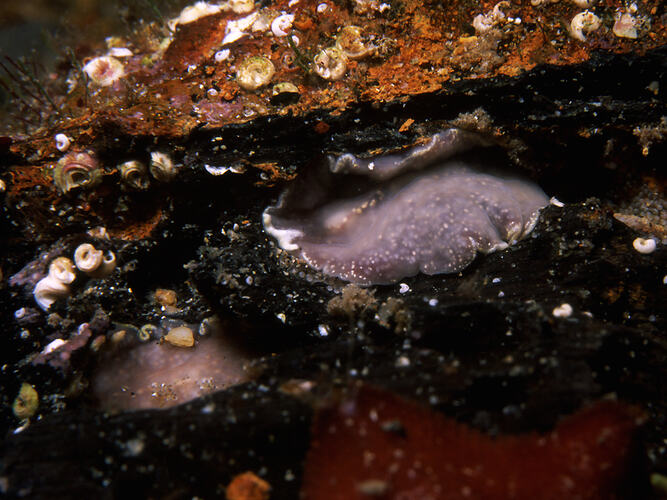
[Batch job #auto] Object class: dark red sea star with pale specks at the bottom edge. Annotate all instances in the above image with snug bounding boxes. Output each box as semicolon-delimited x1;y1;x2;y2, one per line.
303;386;646;500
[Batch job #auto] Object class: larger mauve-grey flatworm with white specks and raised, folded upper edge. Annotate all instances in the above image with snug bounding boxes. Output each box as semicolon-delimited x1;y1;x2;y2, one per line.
264;129;549;285
